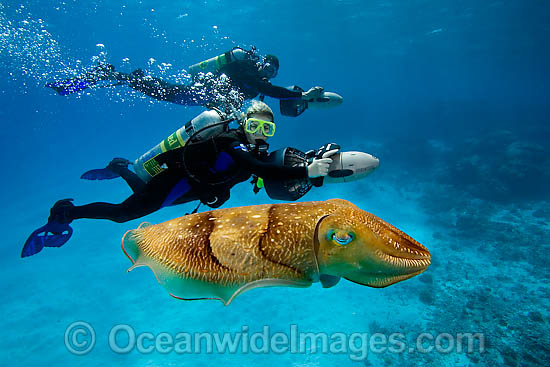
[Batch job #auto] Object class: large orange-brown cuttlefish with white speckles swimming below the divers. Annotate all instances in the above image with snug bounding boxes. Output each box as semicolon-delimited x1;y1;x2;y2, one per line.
122;199;430;305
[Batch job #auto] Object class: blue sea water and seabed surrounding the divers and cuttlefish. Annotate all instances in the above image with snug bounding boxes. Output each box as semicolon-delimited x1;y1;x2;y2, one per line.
0;0;550;366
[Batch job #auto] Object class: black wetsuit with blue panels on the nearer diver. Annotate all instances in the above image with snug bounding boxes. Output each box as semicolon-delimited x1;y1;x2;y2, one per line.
67;130;307;223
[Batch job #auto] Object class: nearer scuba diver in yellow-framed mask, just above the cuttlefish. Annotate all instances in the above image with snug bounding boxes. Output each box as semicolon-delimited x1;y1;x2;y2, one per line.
21;100;339;257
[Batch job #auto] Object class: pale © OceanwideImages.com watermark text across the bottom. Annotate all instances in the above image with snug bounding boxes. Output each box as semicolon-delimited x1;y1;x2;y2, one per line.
65;321;485;361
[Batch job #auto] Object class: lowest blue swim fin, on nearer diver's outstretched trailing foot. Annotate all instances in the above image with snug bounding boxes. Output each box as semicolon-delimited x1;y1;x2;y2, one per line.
21;220;73;257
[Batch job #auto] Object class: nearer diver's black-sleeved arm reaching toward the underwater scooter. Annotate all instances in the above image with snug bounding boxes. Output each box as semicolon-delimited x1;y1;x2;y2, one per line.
229;143;308;179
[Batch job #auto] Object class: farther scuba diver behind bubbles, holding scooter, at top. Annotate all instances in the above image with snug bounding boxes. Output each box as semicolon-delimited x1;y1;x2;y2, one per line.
46;47;343;117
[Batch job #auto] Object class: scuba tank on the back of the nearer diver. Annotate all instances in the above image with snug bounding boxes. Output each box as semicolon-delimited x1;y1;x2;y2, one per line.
134;109;226;183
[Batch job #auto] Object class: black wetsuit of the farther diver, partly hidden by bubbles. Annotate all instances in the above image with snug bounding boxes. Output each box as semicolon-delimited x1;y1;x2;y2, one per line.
122;60;302;106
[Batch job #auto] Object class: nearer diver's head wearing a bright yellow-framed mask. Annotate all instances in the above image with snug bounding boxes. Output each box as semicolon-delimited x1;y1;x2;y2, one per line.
243;100;275;144
